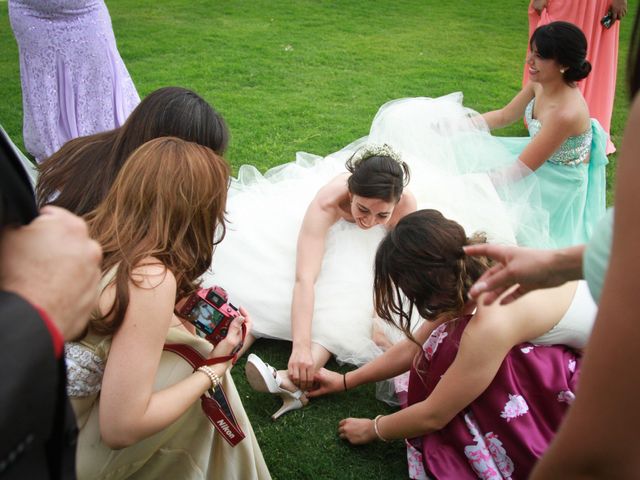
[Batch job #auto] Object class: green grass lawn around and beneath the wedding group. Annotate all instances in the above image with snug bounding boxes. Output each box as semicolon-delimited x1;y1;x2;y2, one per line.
0;0;637;479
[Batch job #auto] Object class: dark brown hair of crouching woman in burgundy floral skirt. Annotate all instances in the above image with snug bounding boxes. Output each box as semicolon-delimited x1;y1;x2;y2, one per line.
374;210;489;339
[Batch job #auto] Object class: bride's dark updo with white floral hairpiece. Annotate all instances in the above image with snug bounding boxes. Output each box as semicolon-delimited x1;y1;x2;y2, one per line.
346;144;409;203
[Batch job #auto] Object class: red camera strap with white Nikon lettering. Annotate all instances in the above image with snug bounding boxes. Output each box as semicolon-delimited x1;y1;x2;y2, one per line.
164;342;245;447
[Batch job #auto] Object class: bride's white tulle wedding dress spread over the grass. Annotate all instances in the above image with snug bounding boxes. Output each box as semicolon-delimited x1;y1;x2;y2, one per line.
203;93;547;365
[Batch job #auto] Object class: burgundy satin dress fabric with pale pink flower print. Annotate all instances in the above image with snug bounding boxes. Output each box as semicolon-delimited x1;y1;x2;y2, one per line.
407;317;580;480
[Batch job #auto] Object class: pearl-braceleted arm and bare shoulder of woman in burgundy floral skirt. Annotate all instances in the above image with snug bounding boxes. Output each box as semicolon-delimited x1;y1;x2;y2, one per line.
338;287;572;444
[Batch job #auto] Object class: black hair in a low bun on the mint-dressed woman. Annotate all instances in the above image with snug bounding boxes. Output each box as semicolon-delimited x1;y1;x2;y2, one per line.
529;22;591;83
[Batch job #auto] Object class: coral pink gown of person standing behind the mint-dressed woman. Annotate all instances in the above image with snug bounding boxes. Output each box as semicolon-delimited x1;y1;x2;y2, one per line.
522;0;620;154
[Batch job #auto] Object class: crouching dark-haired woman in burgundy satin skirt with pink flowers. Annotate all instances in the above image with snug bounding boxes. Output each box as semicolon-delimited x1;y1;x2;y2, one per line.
308;210;595;479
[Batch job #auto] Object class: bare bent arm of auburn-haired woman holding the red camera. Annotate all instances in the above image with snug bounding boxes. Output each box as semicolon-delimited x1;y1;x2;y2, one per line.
99;263;239;449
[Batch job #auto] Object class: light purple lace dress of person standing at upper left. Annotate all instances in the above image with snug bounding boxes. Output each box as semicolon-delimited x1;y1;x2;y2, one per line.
9;0;140;162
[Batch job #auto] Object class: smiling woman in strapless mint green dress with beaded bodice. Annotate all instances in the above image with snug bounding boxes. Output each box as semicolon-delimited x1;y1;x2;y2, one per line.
483;22;607;247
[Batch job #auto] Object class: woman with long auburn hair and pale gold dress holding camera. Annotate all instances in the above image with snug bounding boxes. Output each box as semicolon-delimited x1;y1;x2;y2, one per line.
66;137;269;479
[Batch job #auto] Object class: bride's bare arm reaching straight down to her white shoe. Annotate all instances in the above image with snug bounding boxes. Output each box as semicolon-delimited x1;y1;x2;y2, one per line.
288;191;336;389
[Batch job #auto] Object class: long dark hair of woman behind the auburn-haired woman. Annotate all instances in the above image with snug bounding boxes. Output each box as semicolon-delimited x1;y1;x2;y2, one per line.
36;87;229;215
